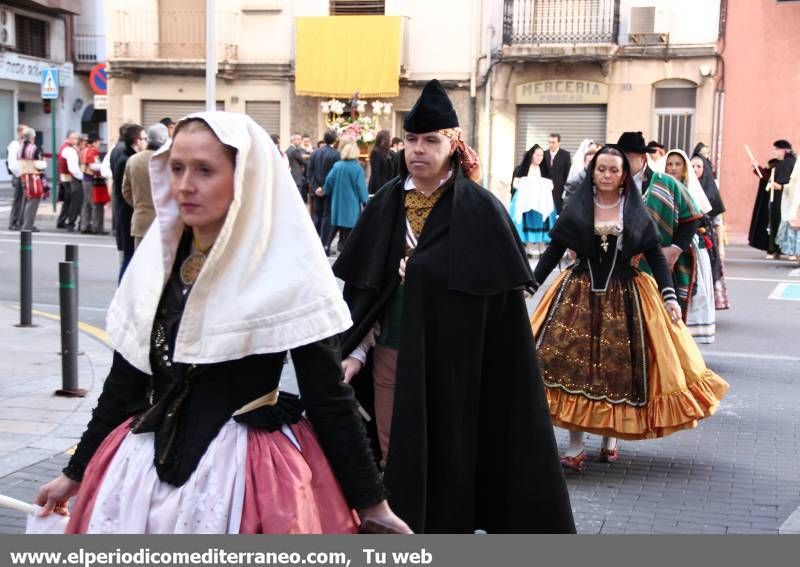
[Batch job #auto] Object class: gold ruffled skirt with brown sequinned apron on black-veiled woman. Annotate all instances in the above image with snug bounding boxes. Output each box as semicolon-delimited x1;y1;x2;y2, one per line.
531;269;728;439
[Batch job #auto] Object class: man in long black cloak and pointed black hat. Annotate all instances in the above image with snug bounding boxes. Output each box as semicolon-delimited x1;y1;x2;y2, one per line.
333;80;575;533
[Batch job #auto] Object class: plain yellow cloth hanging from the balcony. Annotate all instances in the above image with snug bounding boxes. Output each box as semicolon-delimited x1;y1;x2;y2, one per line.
294;16;403;98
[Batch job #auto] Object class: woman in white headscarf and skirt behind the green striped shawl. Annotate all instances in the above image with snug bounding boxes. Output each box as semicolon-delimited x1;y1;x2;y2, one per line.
664;150;717;344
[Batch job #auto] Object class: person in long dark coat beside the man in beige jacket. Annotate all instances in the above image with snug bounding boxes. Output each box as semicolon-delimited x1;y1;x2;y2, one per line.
110;124;147;280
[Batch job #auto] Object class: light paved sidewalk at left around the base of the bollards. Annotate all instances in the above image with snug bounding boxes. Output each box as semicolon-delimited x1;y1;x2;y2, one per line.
0;304;111;533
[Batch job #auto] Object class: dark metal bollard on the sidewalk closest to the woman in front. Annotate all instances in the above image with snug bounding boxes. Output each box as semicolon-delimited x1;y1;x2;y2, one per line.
56;262;86;397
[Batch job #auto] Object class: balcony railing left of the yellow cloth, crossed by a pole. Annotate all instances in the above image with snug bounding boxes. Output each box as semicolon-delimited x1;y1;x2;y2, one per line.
113;10;239;61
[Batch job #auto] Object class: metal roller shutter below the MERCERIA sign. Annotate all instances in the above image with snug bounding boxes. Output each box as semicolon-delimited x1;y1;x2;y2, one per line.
515;104;606;163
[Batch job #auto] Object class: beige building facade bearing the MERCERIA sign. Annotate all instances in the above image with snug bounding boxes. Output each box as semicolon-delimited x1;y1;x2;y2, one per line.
481;0;719;199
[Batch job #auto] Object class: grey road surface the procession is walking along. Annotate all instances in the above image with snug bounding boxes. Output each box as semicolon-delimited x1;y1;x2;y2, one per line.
0;186;800;533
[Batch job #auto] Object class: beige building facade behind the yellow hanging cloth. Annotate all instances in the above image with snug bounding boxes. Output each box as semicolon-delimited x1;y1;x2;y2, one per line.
108;0;482;147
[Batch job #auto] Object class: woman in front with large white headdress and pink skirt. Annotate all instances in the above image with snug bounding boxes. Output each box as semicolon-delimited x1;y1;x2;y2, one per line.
37;112;408;533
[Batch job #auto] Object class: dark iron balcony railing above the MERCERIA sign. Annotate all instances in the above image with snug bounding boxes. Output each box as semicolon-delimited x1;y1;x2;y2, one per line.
503;0;619;45
